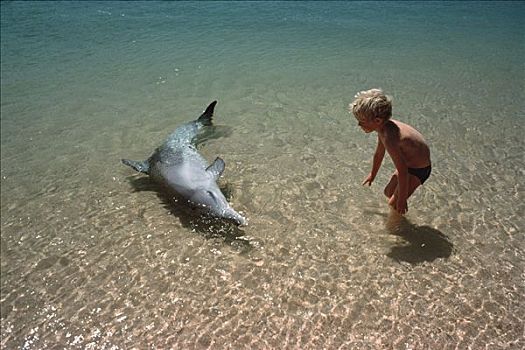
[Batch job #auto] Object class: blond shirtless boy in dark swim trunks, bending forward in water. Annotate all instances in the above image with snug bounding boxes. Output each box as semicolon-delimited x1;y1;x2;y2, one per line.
350;89;431;214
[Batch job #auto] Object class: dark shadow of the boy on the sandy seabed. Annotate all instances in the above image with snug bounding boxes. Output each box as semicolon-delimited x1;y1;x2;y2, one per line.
366;210;454;265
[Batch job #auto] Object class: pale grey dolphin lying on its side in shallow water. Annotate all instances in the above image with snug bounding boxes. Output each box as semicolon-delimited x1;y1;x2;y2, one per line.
122;101;247;225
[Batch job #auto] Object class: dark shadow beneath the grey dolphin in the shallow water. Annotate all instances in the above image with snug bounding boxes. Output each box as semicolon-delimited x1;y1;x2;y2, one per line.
128;176;254;252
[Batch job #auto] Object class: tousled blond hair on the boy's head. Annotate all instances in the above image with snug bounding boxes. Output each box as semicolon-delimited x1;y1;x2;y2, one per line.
349;89;392;120
